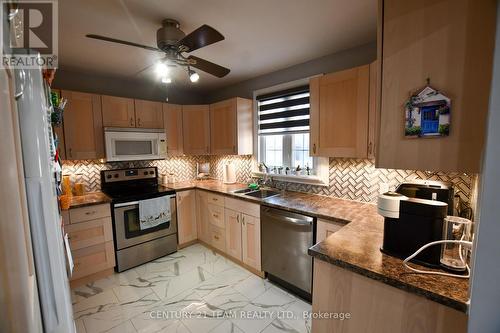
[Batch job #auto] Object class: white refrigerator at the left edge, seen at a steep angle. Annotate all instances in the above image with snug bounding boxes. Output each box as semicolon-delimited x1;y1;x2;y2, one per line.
0;61;75;333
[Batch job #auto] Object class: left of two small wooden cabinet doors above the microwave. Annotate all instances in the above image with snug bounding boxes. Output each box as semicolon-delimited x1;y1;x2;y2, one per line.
101;95;135;127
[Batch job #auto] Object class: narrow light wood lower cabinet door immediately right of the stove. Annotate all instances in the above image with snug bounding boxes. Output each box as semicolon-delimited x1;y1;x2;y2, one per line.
177;190;197;245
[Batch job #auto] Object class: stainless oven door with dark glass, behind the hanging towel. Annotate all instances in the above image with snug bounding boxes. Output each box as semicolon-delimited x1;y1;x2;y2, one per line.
113;195;177;250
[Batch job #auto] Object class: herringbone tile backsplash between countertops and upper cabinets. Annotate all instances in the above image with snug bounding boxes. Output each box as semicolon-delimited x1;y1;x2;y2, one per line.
63;156;477;202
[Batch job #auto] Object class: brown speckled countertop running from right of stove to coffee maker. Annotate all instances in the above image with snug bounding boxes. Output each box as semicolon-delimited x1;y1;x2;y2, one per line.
163;180;469;312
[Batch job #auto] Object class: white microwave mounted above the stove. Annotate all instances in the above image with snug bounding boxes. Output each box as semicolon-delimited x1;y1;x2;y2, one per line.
104;127;167;162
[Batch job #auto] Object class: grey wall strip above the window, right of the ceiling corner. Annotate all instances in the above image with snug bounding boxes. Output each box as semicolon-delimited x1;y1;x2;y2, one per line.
201;42;377;103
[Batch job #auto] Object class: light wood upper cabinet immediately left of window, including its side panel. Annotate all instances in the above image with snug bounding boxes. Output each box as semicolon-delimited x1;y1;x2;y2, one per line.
210;97;253;155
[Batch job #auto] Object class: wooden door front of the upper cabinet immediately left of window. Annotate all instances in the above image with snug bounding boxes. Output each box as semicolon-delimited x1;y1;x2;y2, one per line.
210;98;238;155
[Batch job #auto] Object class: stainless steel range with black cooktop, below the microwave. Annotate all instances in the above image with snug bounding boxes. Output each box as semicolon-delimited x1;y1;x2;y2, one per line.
101;167;177;272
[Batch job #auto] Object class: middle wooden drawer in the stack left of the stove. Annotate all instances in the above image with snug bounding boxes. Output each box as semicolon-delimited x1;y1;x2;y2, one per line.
66;217;113;250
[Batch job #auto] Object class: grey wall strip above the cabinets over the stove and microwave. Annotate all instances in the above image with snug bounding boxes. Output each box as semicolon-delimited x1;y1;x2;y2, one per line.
53;69;203;104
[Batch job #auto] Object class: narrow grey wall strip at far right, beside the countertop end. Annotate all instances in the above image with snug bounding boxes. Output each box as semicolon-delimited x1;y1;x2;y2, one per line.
468;1;500;333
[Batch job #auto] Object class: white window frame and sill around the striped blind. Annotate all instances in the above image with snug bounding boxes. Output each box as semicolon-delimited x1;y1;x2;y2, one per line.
252;75;329;186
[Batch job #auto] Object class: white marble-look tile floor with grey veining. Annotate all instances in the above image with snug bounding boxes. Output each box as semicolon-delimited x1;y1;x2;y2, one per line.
72;244;311;333
